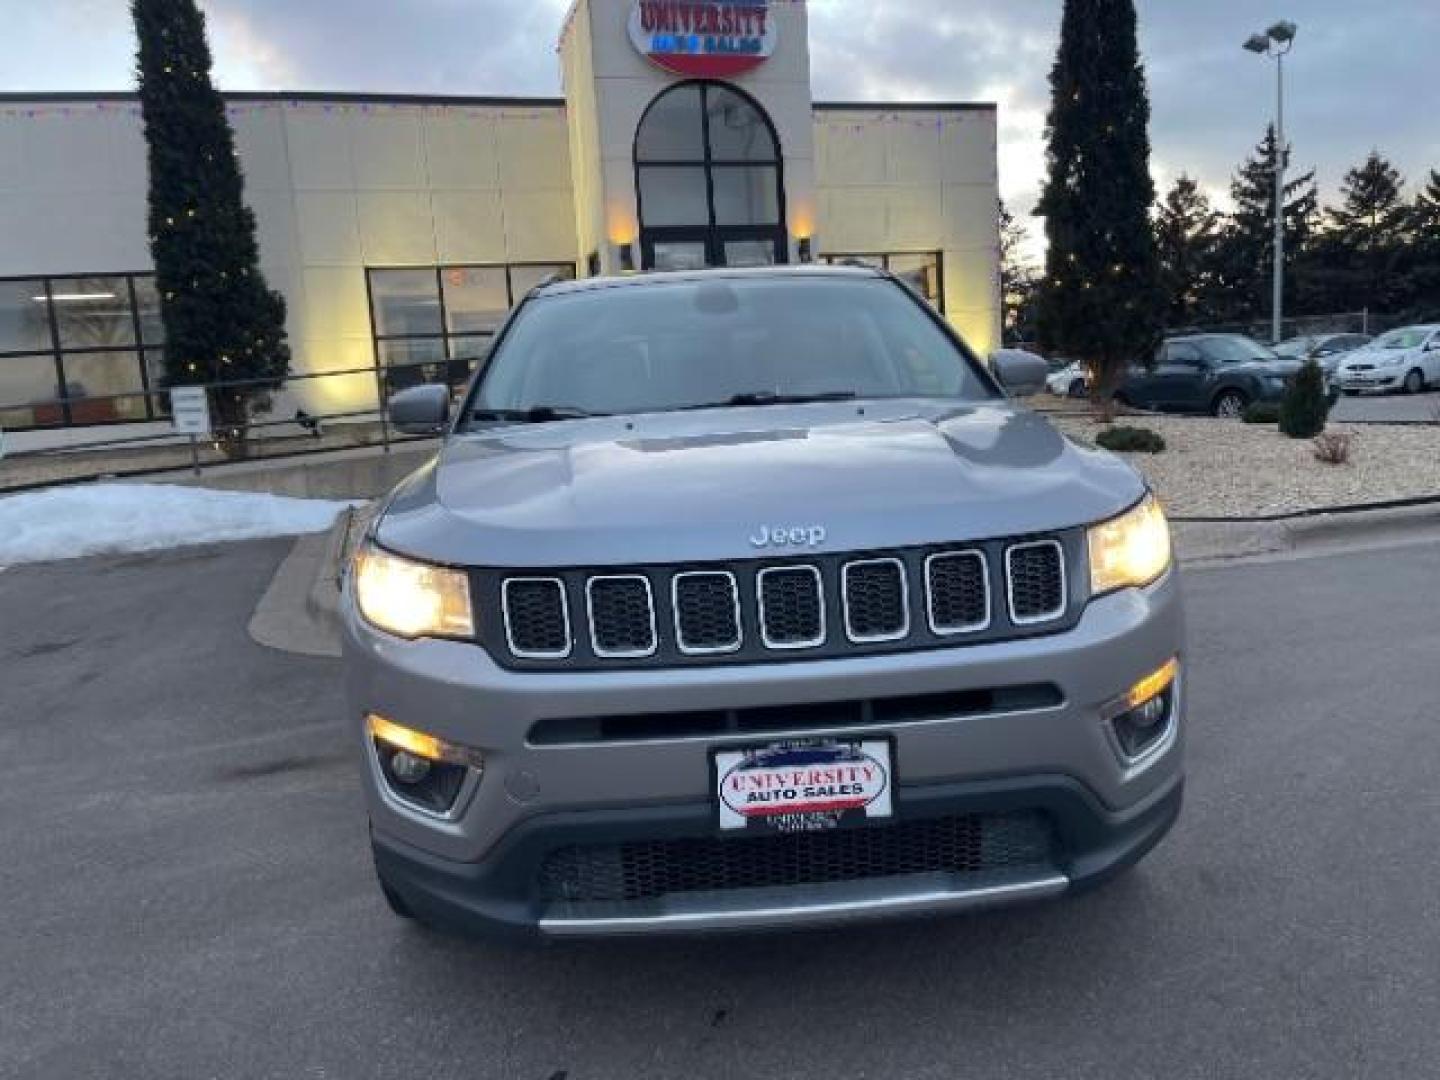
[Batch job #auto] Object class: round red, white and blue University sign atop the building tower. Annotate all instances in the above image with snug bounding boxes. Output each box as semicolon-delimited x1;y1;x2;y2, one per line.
629;0;779;78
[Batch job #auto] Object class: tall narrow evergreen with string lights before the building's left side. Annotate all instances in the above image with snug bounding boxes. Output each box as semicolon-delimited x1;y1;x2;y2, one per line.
131;0;289;455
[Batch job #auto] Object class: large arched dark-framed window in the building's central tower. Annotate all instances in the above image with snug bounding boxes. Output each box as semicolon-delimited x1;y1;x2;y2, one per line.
635;82;786;269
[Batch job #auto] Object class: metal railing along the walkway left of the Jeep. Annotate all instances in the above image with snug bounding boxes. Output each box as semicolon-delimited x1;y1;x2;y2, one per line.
0;360;468;492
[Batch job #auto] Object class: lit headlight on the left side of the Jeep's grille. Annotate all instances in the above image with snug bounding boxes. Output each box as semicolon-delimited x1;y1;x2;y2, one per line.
354;546;475;638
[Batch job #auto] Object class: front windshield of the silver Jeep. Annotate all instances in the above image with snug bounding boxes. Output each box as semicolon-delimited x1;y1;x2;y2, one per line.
468;275;995;422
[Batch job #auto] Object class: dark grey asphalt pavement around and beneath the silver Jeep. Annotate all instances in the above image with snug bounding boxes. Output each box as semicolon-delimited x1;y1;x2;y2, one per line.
0;541;1440;1080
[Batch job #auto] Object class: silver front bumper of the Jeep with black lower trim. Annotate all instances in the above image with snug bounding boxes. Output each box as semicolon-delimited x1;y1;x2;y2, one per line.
344;572;1184;935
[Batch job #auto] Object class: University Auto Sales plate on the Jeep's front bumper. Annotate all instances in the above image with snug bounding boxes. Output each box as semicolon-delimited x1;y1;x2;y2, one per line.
714;739;894;832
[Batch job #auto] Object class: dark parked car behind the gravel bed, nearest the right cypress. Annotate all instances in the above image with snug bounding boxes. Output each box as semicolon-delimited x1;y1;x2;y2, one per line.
1115;334;1300;418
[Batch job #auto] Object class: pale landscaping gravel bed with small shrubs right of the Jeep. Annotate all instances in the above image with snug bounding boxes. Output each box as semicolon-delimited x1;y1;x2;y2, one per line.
1050;413;1440;517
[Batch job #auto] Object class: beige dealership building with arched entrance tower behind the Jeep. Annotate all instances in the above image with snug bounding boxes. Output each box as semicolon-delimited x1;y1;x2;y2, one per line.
0;0;999;431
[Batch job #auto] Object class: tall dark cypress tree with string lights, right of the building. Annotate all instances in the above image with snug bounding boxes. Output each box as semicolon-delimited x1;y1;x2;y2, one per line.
1035;0;1165;410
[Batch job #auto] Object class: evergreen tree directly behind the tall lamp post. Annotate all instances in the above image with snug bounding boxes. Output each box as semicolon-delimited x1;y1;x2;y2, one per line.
1215;125;1319;321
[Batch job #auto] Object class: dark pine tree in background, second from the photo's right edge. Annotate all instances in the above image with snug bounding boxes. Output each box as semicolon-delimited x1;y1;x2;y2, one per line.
1328;150;1410;311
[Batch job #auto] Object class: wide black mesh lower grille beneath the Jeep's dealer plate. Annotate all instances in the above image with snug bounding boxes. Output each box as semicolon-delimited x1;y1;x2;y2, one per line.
539;811;1054;903
